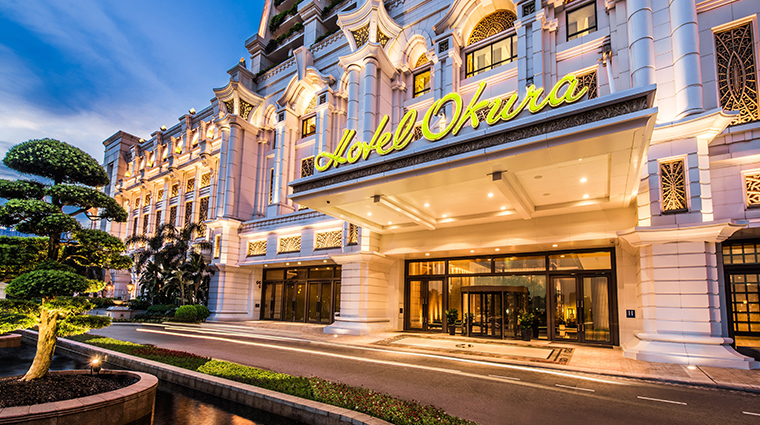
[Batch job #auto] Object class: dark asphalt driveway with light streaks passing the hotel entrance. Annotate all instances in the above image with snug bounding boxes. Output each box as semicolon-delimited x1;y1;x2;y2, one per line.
91;325;760;425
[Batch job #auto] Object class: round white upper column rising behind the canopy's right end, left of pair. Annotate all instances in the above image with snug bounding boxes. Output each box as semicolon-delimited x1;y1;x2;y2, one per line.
626;0;656;87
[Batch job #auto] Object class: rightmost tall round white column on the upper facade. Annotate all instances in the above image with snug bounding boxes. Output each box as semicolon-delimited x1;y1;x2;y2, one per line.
669;0;704;119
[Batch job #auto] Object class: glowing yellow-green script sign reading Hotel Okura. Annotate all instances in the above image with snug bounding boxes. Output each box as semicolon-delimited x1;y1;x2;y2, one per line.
314;74;588;171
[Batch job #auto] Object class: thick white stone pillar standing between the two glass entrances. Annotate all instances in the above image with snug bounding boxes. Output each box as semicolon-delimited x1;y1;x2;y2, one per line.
324;252;393;335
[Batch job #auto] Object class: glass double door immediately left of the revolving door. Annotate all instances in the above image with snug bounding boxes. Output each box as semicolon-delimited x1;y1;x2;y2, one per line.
409;279;444;331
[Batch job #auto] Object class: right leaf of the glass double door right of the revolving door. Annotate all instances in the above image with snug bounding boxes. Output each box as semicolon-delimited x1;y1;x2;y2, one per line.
583;277;610;341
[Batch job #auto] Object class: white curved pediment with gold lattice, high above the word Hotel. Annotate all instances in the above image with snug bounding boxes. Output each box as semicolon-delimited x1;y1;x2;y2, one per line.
338;0;403;52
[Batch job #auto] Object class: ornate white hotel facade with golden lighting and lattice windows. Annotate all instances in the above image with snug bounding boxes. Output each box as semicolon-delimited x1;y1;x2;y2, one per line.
102;0;760;369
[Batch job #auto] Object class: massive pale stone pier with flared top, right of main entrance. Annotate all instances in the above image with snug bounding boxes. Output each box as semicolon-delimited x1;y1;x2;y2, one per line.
619;222;760;369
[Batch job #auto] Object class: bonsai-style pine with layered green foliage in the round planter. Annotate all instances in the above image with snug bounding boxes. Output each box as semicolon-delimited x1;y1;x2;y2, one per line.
0;139;131;381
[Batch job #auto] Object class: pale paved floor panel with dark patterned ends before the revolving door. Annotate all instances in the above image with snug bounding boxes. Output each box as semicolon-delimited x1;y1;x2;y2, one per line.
374;335;574;364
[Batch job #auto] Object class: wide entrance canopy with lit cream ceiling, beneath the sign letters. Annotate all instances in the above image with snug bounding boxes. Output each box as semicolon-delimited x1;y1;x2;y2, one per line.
291;86;657;233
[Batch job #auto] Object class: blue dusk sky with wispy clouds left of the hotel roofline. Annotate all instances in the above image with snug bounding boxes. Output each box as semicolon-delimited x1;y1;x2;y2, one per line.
0;0;264;178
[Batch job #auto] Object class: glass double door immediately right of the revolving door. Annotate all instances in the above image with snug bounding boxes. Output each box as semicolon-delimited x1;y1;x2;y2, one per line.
552;276;611;342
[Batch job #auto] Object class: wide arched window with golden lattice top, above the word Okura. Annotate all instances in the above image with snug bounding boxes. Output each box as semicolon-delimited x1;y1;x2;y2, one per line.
465;10;517;78
